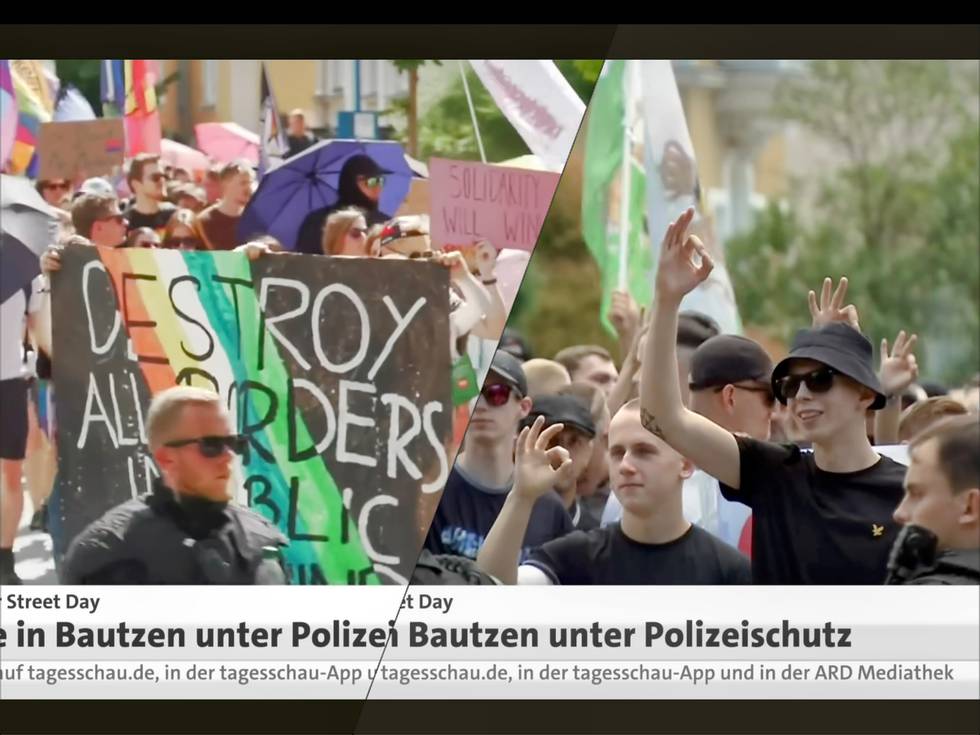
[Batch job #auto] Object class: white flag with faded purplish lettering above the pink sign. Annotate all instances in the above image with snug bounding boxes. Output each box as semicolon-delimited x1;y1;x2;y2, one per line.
470;59;585;173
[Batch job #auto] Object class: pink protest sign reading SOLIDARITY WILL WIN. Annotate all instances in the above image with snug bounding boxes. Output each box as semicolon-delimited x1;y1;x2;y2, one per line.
429;158;558;251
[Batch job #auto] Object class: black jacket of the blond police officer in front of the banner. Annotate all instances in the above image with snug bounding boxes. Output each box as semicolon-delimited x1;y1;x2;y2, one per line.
62;480;288;585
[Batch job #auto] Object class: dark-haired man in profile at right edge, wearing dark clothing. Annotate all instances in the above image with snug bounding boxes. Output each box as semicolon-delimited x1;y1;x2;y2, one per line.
887;416;980;584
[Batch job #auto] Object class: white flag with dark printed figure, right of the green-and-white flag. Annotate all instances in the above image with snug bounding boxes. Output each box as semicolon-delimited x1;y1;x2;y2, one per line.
637;61;742;334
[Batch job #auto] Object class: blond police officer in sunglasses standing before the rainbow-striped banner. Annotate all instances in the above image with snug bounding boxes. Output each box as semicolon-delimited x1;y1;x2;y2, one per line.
62;387;287;584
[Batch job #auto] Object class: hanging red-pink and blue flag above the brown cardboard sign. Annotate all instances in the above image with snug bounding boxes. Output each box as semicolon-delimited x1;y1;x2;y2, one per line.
99;59;162;158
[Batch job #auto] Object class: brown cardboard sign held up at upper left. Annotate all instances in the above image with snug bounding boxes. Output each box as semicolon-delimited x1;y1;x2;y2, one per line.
37;118;126;180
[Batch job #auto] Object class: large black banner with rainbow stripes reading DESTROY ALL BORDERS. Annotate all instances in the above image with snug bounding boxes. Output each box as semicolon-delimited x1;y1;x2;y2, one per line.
52;246;453;584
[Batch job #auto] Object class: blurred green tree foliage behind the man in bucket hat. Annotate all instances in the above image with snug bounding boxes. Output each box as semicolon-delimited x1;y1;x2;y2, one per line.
728;61;980;382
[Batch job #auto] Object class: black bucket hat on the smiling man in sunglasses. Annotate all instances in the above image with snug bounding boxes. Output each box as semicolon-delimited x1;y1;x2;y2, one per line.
771;322;887;411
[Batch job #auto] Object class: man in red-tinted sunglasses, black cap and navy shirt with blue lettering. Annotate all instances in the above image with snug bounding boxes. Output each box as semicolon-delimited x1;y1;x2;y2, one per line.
425;351;573;559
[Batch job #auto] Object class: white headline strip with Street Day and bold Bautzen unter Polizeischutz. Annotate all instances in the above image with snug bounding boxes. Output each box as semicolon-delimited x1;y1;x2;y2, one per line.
0;587;980;664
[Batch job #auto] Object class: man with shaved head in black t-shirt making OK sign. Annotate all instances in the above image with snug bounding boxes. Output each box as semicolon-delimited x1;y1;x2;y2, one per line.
477;400;751;585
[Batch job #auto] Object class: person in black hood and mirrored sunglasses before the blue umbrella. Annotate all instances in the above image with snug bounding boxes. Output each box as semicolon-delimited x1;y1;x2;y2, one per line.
295;154;391;255
